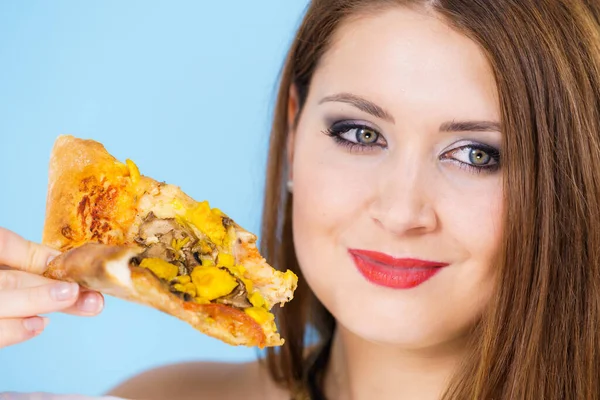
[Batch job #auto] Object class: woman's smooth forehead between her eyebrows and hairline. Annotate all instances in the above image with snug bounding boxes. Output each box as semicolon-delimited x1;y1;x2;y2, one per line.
311;7;498;119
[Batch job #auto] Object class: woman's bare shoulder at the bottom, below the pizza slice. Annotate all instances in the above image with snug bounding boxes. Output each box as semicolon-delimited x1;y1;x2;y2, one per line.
109;361;289;400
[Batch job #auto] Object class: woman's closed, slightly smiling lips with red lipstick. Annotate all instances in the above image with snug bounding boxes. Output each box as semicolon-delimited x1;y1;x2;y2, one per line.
348;249;449;289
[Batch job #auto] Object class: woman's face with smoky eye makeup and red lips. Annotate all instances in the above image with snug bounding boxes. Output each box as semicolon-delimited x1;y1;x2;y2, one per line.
291;8;503;348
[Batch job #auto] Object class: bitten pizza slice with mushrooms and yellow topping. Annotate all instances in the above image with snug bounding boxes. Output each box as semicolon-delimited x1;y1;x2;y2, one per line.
42;136;298;348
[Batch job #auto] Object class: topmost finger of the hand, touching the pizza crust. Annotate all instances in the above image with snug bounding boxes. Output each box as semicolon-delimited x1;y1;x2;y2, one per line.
0;228;60;274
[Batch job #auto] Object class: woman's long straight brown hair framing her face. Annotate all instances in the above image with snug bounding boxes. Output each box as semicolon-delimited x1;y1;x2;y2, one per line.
261;0;600;400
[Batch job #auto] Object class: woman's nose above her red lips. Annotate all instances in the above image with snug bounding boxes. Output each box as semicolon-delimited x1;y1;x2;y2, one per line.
370;160;438;235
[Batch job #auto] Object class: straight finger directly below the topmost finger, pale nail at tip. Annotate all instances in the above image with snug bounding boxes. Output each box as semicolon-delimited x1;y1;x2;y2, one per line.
0;282;79;318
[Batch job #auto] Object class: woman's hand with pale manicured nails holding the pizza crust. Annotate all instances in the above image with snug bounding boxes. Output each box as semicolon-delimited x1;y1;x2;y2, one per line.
0;228;104;349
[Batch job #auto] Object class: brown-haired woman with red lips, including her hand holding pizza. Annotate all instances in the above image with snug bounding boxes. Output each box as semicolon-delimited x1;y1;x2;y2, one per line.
0;0;600;400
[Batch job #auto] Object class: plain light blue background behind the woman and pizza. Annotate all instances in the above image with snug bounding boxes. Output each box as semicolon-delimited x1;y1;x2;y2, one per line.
0;0;307;395
